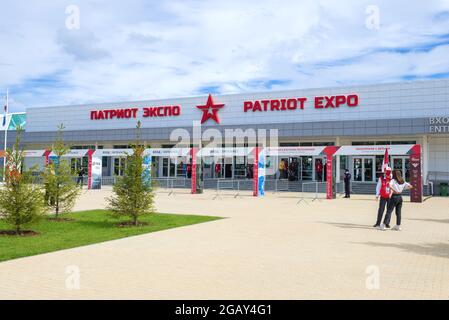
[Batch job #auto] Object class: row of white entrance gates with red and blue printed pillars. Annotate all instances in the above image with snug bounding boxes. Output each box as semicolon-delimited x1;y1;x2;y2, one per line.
14;144;422;202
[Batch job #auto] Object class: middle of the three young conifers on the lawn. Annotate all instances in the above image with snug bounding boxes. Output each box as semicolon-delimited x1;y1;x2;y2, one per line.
42;124;81;220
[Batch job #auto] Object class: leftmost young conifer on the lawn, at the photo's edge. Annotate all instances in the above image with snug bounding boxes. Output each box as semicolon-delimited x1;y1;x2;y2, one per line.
0;128;45;235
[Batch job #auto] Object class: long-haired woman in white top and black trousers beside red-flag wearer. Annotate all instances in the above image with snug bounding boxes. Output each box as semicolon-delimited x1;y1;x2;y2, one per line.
384;170;413;231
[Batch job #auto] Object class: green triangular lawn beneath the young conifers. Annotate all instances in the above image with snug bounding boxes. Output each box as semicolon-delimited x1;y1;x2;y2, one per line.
0;210;221;261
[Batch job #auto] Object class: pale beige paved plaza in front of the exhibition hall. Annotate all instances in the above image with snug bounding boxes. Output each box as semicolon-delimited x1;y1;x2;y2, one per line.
0;189;449;299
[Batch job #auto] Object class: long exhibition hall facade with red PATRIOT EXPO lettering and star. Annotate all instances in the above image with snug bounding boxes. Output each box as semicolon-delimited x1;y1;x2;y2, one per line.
3;80;449;194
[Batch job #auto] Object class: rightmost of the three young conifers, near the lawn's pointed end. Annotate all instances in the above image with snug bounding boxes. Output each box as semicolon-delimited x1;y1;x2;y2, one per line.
108;121;154;226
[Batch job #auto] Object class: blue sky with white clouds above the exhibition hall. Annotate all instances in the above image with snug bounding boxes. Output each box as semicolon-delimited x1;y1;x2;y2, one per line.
0;0;449;111
